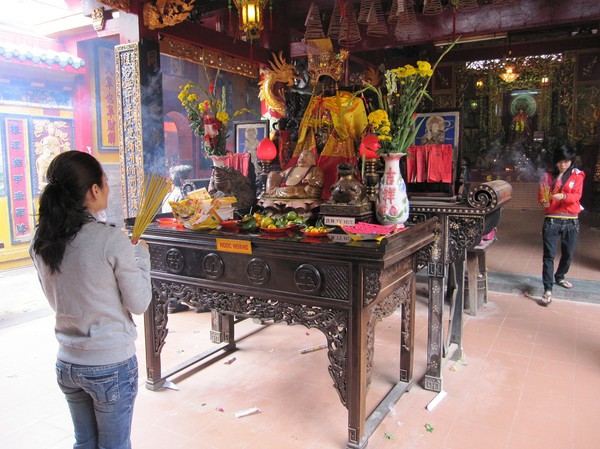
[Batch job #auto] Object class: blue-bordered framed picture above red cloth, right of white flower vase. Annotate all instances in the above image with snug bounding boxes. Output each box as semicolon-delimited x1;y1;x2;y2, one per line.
414;111;460;150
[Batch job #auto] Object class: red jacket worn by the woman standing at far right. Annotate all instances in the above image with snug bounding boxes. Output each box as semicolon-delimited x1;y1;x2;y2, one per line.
538;168;585;218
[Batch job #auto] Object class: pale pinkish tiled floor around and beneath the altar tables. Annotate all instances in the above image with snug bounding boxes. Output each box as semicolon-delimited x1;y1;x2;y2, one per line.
0;211;600;449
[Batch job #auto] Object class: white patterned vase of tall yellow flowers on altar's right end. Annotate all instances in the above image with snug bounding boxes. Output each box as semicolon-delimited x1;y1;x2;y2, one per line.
366;39;458;225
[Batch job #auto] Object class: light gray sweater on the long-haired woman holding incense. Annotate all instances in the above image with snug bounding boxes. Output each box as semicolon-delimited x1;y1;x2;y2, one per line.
30;221;152;365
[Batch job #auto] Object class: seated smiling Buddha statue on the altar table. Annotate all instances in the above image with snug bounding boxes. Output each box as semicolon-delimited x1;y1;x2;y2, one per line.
264;149;323;199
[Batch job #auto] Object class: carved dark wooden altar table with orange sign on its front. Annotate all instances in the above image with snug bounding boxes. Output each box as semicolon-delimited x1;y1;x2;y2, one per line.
142;218;438;448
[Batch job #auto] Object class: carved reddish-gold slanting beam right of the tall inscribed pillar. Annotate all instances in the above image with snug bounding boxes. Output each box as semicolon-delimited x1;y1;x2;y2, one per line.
160;36;259;79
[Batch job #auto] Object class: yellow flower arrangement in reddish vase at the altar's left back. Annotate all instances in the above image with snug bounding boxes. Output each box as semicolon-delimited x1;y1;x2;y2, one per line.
178;71;251;165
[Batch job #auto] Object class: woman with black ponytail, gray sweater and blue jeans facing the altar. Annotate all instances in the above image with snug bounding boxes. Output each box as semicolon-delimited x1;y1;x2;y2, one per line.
30;151;152;449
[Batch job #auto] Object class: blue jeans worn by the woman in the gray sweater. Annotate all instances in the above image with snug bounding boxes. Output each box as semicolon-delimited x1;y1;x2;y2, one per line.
56;356;138;449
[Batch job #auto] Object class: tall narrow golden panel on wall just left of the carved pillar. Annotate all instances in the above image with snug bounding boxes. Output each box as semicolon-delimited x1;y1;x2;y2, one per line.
95;45;119;151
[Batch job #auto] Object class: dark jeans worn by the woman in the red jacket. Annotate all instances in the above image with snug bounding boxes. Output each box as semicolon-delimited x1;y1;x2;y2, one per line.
542;218;579;291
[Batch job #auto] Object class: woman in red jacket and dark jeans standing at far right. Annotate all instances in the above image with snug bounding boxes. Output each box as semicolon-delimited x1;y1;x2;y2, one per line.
538;145;585;306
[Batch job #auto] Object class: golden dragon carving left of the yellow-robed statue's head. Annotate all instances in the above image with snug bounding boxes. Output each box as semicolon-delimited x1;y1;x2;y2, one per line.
258;51;298;117
